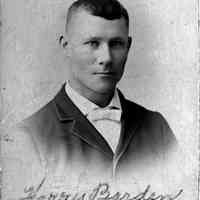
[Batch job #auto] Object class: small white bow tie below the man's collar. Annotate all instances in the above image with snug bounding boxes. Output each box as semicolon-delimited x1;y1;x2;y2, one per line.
87;107;121;122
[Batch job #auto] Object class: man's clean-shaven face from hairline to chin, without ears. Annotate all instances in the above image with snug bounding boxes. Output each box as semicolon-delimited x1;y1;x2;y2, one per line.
66;10;131;95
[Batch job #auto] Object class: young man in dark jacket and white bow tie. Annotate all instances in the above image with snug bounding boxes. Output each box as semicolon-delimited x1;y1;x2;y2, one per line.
3;0;176;195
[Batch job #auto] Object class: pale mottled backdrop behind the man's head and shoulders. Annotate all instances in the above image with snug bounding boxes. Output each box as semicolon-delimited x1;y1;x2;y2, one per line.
0;0;199;199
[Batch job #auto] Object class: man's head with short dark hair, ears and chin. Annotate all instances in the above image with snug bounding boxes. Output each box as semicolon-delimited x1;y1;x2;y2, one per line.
63;0;131;103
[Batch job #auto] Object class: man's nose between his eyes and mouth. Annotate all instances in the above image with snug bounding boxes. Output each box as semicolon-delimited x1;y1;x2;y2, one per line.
97;43;112;65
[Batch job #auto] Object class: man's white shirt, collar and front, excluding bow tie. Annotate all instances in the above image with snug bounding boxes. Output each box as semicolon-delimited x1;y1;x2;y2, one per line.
65;83;122;152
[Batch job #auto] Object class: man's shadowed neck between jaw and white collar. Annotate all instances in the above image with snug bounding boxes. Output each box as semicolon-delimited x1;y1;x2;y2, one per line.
69;81;115;107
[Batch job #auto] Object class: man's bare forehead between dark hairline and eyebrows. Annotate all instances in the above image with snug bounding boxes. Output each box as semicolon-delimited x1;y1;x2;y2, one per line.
67;10;128;37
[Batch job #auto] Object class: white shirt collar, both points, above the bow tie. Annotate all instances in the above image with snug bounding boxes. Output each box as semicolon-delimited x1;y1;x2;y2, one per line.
65;82;121;115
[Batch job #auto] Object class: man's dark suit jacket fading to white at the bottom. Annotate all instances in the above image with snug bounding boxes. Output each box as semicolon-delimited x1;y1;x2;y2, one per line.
3;86;176;195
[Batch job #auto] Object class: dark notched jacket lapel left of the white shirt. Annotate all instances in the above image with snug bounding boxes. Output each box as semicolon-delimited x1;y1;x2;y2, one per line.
54;85;113;158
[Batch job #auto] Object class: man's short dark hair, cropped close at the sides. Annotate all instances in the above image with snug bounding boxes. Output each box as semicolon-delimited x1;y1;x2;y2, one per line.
66;0;129;30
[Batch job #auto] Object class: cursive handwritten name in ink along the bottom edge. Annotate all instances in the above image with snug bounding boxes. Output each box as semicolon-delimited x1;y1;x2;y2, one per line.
19;179;183;200
